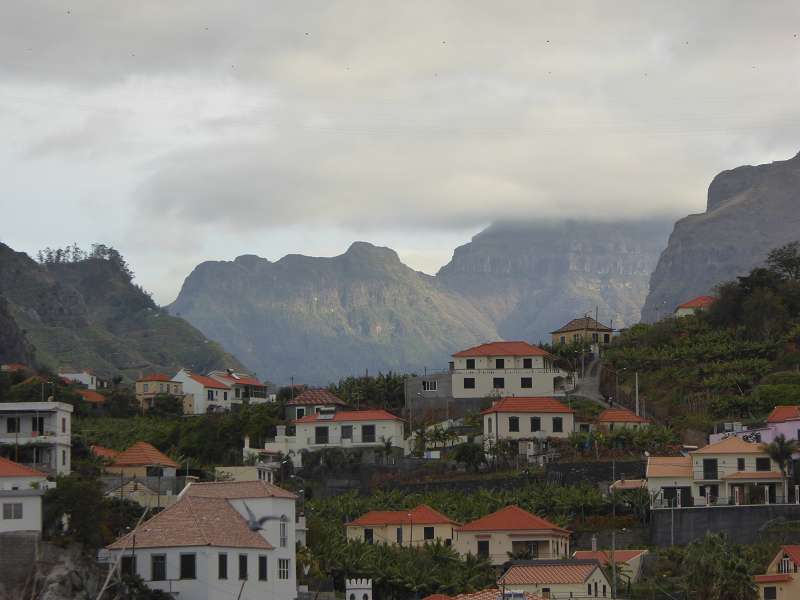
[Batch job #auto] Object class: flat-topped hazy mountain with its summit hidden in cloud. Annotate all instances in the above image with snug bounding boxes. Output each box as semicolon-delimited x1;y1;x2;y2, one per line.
437;221;669;341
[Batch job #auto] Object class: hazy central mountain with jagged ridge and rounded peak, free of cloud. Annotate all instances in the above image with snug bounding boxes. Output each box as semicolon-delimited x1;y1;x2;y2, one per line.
169;242;497;384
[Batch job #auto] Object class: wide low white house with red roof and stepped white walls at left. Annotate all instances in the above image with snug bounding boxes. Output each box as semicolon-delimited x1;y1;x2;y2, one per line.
250;408;405;468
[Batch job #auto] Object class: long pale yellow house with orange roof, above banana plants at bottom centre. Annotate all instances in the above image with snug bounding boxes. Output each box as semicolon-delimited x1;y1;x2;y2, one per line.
345;504;460;546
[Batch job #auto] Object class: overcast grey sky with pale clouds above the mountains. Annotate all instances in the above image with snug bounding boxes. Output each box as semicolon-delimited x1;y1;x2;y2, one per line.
0;0;800;303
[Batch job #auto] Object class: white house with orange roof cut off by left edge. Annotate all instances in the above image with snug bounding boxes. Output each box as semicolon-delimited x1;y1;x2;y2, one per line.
0;458;48;533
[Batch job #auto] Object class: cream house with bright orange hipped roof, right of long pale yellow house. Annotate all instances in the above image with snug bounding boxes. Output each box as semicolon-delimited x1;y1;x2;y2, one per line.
454;506;570;565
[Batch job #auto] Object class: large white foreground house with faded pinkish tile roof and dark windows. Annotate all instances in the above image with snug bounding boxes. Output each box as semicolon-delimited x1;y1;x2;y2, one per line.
100;481;297;600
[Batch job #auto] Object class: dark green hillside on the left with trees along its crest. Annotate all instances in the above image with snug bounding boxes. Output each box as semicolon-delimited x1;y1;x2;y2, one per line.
0;243;240;378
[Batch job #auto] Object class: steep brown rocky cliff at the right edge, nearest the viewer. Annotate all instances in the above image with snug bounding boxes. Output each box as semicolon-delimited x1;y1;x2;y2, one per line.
642;154;800;321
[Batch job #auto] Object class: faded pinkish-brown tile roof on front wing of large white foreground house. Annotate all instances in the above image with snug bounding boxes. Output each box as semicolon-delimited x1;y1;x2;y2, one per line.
108;497;273;550
